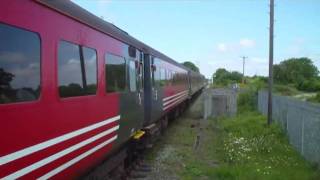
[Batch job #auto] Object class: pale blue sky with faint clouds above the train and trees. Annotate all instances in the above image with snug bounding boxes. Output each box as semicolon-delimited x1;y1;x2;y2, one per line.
72;0;320;78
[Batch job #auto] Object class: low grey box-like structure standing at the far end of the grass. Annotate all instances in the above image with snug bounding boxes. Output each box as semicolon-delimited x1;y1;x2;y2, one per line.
203;89;237;119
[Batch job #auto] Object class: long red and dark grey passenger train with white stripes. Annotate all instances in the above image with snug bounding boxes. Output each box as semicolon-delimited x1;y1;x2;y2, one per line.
0;0;205;179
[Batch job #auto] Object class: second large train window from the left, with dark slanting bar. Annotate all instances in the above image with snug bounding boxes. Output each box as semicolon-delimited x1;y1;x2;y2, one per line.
58;41;97;97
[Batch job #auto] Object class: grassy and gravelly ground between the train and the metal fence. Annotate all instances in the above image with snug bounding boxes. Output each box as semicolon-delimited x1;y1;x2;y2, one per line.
144;90;320;180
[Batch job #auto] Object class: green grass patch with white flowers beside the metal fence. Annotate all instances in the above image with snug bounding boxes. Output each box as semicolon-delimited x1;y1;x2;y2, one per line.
214;111;320;180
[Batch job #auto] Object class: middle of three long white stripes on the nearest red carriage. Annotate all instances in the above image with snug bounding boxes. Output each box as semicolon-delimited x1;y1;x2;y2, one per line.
0;125;119;180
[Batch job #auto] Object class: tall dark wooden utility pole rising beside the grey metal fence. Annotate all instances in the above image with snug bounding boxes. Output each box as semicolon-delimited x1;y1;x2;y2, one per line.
268;0;274;125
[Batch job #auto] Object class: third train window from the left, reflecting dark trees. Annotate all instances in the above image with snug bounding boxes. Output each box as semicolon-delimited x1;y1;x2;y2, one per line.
105;54;126;92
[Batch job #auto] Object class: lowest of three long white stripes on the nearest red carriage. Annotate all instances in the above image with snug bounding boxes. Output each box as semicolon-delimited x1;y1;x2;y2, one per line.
38;135;117;180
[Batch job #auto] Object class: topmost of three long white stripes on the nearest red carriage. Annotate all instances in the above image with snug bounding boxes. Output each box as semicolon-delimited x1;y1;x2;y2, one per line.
0;115;120;165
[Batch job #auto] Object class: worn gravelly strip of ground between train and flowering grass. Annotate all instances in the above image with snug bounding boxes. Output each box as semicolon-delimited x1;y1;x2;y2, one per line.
144;96;217;180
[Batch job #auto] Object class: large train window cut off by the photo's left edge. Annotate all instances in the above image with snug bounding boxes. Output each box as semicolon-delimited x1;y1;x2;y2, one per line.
0;23;41;104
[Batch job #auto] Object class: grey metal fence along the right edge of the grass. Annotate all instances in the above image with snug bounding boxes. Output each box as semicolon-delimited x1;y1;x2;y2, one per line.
258;91;320;164
